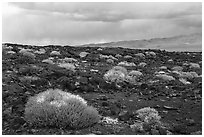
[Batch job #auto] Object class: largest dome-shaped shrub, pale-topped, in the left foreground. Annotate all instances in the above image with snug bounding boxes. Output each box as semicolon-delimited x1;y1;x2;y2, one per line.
25;89;99;128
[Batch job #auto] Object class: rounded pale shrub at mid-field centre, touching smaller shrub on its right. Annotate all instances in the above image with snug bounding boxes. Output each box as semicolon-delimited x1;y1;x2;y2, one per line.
104;66;127;83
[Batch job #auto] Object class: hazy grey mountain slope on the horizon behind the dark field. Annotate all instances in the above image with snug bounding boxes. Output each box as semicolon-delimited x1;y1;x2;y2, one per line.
80;33;202;52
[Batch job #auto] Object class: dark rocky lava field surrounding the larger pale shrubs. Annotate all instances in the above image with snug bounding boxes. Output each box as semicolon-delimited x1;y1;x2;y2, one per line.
2;43;202;135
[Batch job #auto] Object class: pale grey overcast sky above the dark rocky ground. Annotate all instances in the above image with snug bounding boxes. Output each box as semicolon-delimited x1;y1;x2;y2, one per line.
2;2;202;45
